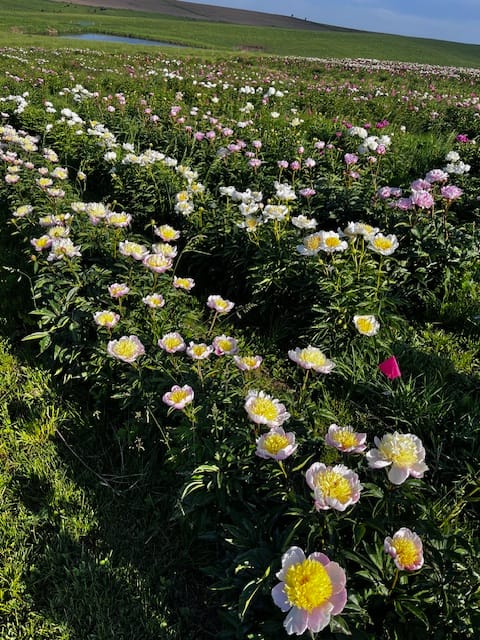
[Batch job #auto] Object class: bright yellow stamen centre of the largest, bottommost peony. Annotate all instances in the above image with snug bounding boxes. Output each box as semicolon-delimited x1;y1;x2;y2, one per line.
285;559;333;613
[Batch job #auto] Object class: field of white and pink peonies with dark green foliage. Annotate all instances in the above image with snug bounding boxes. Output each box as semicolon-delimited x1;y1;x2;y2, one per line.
0;48;480;640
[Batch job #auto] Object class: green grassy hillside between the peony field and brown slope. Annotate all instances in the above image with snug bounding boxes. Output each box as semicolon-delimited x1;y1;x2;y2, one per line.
0;0;480;67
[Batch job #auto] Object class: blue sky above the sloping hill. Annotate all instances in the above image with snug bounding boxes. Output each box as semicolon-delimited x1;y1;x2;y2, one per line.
183;0;480;44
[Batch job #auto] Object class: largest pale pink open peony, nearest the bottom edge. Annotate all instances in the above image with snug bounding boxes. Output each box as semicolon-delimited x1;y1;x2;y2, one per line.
272;547;347;635
